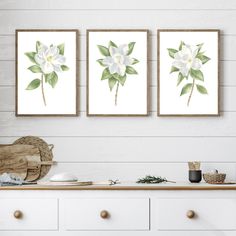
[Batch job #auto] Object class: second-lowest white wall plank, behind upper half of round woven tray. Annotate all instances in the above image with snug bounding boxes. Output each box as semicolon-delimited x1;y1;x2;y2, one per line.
0;137;236;163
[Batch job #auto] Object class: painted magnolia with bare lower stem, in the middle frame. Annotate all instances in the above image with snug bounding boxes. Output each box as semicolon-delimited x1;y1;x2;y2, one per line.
97;41;139;106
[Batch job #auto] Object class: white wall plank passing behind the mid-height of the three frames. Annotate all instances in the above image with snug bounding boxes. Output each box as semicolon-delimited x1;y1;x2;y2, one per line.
0;61;236;86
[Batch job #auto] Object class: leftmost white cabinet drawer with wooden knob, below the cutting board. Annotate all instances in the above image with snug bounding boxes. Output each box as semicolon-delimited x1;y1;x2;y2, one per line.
0;199;58;230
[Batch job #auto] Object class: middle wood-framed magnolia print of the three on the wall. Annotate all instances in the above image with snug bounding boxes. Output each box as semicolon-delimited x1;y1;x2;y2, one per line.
87;30;148;116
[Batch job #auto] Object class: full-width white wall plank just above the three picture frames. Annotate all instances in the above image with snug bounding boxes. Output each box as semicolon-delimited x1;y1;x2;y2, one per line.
0;10;236;34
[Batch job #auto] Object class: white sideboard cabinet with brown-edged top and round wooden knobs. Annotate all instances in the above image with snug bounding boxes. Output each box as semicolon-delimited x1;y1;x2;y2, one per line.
0;184;236;236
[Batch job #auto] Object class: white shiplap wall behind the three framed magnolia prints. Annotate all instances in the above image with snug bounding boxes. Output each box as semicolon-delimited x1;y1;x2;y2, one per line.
0;0;236;181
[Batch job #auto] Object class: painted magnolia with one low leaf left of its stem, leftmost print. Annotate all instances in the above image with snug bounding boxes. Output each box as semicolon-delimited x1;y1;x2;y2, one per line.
25;41;69;106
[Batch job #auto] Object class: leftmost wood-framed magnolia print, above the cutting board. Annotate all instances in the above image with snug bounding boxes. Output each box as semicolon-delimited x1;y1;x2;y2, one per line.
16;30;78;116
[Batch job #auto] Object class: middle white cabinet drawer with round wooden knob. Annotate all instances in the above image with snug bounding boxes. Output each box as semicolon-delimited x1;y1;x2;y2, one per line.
65;199;149;230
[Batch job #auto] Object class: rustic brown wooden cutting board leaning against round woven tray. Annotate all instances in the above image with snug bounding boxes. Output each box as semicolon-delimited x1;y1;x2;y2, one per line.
0;144;41;181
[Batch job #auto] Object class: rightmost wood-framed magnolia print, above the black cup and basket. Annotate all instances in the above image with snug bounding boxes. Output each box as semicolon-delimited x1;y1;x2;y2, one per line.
158;29;220;116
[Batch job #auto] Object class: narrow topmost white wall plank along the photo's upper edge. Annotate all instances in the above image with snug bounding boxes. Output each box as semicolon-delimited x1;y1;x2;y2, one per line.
0;0;236;10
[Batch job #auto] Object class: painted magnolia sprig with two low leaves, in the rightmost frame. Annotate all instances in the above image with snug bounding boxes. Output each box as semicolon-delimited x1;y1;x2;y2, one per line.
167;41;211;106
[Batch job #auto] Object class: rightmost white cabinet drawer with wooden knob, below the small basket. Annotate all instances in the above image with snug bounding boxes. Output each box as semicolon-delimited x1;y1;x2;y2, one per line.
155;199;236;230
